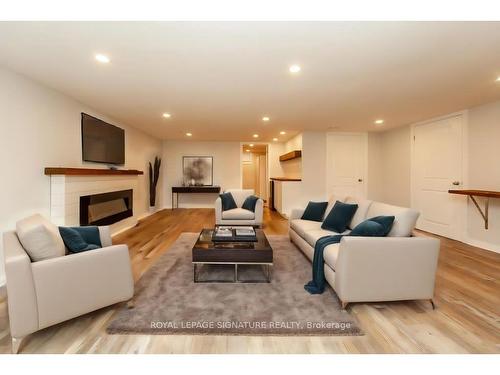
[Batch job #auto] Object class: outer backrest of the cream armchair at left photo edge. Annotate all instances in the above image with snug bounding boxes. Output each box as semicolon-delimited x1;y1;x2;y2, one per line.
3;231;38;338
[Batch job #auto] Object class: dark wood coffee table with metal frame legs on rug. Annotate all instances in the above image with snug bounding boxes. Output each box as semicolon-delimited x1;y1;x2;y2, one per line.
193;229;273;283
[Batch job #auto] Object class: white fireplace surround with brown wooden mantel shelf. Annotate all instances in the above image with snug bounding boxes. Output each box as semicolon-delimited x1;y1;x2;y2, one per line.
45;168;144;233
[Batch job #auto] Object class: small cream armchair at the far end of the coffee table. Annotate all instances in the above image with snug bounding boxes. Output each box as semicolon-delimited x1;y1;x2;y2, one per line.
215;189;264;227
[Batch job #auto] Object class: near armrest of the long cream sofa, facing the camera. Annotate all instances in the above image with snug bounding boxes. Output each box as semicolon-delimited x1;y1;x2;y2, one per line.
334;236;439;302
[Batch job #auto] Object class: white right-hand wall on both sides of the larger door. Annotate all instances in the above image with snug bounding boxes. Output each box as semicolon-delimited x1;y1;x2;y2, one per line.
368;101;500;252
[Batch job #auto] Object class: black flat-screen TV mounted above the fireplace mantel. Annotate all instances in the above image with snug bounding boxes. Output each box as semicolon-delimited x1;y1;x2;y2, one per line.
82;113;125;164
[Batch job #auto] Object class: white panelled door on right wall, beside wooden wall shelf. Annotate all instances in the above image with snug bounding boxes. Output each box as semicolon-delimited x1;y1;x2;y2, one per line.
412;115;464;240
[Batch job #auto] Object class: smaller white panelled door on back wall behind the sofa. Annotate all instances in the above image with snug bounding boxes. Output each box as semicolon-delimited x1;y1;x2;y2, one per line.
326;133;367;199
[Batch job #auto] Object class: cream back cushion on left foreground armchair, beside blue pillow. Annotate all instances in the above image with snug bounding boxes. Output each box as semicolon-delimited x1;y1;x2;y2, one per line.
16;214;66;262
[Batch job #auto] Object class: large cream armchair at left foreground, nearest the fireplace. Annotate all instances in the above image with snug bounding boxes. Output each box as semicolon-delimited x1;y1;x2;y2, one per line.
3;215;134;353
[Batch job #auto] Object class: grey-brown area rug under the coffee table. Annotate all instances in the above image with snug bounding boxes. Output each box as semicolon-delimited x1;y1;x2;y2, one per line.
107;233;362;336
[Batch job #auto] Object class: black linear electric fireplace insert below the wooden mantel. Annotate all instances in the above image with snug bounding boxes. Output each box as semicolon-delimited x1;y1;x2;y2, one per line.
80;189;134;225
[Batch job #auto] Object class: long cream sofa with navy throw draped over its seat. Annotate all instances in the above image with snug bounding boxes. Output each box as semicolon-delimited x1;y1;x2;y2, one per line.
289;197;439;308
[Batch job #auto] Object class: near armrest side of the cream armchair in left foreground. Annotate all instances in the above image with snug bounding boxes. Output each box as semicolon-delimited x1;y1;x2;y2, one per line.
32;245;134;329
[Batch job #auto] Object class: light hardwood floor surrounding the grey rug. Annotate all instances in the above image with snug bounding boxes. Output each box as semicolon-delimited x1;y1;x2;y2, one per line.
0;209;500;353
